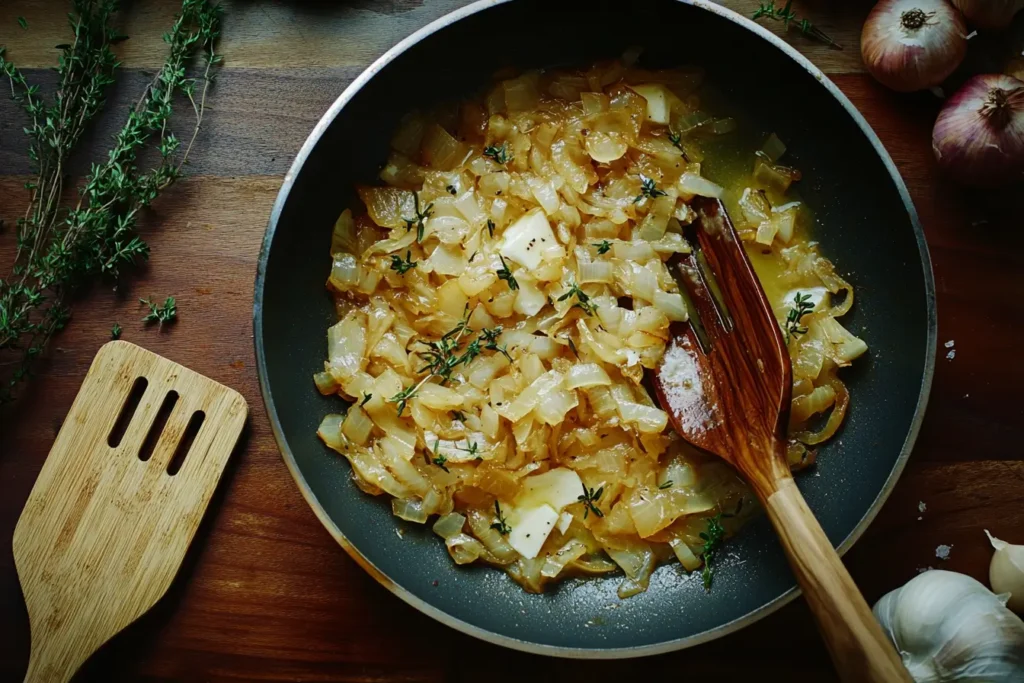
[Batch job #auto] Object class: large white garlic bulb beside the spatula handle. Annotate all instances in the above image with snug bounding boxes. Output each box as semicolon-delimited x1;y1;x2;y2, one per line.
873;569;1024;683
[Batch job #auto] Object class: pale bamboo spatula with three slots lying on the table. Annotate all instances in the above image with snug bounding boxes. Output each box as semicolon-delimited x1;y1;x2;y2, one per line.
14;341;248;683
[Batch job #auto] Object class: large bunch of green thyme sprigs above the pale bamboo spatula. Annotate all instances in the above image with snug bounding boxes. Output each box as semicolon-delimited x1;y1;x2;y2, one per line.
0;0;221;403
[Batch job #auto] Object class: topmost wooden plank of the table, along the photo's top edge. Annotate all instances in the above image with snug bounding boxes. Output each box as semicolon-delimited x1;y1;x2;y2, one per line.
0;0;871;74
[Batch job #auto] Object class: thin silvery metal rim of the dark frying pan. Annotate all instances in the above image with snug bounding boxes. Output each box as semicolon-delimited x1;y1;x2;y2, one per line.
253;0;938;659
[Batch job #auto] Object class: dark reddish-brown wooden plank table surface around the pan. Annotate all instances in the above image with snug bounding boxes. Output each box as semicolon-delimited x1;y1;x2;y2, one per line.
0;0;1024;683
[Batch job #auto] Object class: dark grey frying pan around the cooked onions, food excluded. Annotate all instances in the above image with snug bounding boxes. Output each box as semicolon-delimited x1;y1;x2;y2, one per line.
254;0;936;657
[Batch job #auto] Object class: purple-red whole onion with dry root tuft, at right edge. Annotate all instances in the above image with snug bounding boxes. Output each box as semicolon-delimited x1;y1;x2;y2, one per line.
932;74;1024;185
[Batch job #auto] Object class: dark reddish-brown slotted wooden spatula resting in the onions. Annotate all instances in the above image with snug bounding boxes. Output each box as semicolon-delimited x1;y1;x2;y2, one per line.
654;198;910;682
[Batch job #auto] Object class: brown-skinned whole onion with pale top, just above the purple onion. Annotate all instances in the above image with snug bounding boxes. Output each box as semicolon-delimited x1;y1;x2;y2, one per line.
860;0;967;92
